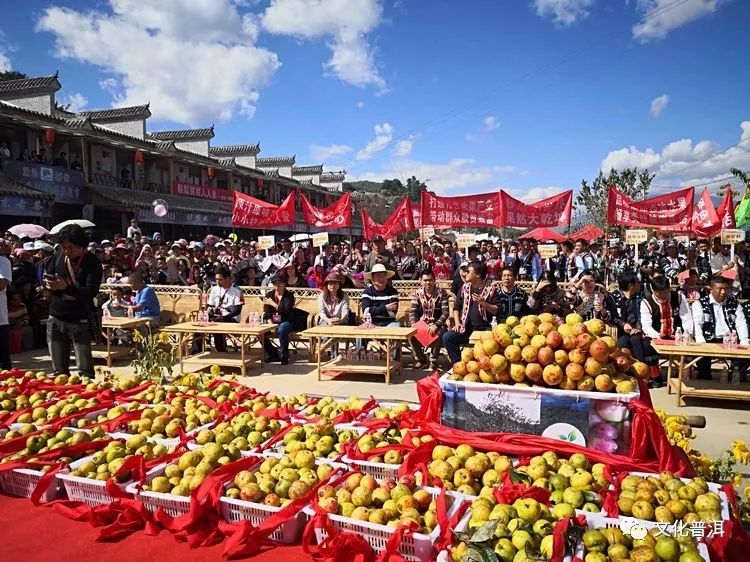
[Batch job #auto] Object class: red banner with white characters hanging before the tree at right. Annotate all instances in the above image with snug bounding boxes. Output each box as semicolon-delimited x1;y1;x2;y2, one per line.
607;187;695;232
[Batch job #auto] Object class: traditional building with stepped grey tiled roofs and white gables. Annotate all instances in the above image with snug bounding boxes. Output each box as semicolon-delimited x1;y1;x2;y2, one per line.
0;70;359;236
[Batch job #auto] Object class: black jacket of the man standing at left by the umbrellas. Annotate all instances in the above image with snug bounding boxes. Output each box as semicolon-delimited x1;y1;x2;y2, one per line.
46;252;102;322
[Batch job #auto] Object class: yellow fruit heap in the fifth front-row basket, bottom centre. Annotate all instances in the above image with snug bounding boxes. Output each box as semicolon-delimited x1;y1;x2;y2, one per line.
318;472;452;533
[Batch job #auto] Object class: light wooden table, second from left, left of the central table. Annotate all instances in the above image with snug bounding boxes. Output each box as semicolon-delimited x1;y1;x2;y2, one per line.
162;322;276;377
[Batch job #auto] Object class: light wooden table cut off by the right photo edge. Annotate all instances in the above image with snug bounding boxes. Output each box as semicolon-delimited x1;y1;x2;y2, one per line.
651;341;750;407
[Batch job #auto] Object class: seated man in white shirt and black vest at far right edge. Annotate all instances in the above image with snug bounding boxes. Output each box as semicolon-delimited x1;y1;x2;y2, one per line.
693;276;750;380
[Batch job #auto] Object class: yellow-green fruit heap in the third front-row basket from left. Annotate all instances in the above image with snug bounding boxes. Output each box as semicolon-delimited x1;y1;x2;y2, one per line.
143;443;240;496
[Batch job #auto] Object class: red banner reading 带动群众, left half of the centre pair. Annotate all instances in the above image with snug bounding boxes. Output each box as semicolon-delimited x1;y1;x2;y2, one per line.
420;191;500;228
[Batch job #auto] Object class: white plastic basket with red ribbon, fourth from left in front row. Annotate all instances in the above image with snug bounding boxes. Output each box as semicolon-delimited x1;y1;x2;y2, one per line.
219;453;347;544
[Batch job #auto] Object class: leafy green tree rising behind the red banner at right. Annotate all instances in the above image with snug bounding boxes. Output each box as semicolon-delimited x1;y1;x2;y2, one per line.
575;168;656;229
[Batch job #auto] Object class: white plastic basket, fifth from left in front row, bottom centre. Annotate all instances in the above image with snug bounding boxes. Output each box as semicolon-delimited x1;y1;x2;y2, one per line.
305;486;463;562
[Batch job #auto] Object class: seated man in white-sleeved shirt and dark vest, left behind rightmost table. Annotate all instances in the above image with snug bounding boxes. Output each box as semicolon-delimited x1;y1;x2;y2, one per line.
641;276;693;388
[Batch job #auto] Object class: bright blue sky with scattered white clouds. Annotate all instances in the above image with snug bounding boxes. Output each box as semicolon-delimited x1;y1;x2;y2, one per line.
0;0;750;200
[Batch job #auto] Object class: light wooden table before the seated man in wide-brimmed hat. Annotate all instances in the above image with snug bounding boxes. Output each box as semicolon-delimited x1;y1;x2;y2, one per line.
300;326;417;384
